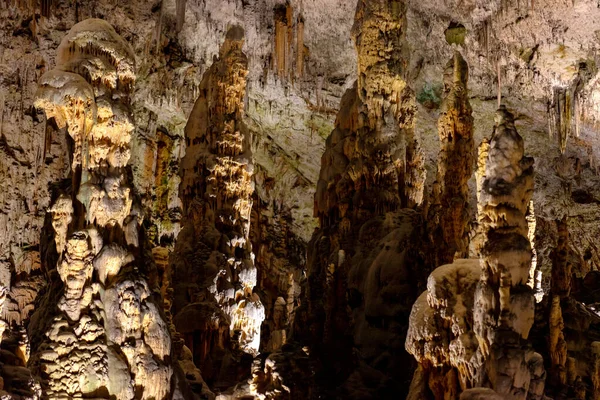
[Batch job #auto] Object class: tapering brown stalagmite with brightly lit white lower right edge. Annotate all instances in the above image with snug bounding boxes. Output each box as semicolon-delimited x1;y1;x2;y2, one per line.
173;27;264;382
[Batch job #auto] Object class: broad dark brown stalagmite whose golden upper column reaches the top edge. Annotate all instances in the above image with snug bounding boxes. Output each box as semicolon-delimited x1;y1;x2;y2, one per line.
302;0;424;390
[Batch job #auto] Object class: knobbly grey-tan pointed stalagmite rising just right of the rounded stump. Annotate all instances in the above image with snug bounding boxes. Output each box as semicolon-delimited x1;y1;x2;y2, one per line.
473;106;543;399
